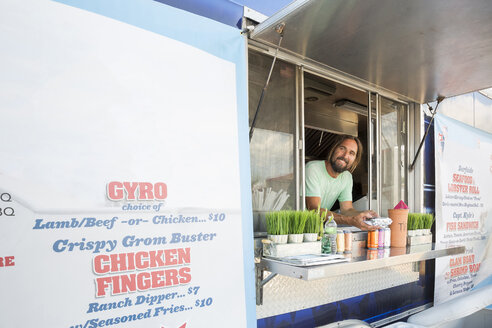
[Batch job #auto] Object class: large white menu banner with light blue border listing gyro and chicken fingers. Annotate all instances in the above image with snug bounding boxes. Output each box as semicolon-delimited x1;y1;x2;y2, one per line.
0;0;256;328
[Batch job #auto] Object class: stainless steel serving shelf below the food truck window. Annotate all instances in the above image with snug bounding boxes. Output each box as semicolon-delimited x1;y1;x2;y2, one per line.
257;244;465;285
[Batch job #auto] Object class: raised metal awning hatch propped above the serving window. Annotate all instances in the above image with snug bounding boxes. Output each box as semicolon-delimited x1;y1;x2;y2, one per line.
251;0;492;103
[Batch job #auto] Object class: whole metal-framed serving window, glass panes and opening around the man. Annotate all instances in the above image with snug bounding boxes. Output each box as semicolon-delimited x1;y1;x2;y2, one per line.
248;50;408;237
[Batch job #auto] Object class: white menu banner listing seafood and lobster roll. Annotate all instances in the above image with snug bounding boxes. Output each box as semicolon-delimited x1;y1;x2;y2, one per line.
434;114;492;304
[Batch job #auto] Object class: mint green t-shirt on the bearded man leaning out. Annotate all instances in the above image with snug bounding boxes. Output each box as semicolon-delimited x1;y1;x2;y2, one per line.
306;161;353;210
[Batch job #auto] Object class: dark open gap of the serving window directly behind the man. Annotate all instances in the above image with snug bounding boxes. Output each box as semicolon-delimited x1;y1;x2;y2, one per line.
304;73;368;210
